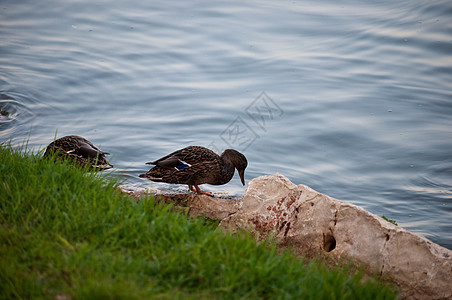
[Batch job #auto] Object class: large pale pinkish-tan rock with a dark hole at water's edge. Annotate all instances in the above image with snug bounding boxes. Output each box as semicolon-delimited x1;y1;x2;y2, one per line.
220;174;452;299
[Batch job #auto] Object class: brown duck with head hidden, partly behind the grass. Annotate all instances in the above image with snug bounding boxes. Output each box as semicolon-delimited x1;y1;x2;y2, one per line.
44;135;113;170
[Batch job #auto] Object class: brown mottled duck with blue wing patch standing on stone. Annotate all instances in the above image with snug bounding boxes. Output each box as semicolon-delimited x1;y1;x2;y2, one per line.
139;146;248;196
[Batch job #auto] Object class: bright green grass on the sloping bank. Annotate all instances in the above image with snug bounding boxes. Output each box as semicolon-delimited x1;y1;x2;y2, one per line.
0;145;396;299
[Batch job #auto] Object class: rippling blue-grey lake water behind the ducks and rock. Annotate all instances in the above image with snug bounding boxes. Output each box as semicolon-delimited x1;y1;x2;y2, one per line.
0;0;452;249
